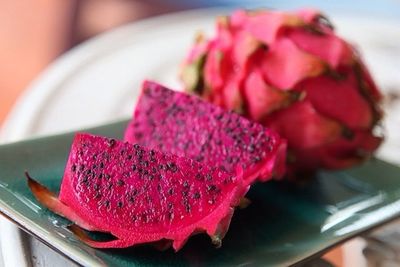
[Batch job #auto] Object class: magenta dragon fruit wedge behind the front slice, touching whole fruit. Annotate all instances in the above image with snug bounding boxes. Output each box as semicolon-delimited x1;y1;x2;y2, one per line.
125;81;286;184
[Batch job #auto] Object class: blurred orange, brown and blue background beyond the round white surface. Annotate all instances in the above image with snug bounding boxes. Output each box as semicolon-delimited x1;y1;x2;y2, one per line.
0;0;400;266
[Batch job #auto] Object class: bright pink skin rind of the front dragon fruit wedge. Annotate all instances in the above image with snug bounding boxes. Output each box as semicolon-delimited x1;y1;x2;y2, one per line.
28;134;249;251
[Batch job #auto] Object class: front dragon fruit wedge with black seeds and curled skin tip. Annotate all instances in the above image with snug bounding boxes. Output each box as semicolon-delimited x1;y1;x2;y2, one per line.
28;134;248;251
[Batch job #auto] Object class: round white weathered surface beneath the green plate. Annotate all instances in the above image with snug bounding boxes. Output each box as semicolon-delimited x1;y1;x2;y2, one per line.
0;9;400;266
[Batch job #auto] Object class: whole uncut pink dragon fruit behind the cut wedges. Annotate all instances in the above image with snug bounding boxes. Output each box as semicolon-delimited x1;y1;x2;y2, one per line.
181;10;382;173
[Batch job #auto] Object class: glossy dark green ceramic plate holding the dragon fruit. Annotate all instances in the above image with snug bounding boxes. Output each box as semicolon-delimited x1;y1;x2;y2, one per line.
0;121;400;266
